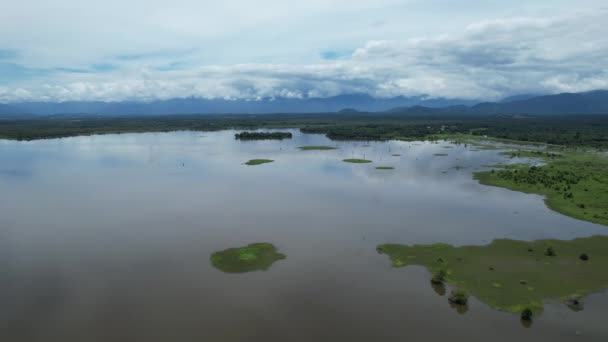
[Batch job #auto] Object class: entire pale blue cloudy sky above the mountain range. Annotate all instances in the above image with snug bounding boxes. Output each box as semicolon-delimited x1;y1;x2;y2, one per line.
0;0;608;103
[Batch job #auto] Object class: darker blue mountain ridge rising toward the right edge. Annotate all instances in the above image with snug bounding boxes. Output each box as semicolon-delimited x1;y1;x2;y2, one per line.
471;90;608;115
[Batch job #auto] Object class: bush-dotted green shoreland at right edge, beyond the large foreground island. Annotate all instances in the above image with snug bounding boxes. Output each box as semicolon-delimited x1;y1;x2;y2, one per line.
474;151;608;225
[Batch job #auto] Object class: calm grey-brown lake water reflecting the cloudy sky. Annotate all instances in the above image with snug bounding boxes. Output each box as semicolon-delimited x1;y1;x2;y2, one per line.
0;130;608;342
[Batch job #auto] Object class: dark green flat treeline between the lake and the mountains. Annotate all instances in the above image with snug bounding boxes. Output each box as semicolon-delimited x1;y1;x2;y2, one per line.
0;113;608;148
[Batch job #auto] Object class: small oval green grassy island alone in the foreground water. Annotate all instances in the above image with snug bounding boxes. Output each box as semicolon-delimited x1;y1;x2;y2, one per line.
210;242;286;273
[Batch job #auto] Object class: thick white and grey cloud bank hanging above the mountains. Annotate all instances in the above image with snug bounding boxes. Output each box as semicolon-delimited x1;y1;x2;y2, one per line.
0;1;608;102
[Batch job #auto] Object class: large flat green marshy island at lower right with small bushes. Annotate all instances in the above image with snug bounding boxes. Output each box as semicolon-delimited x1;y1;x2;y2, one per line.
378;236;608;316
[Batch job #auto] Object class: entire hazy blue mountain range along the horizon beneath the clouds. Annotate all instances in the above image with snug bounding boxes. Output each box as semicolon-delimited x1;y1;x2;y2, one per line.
0;90;608;118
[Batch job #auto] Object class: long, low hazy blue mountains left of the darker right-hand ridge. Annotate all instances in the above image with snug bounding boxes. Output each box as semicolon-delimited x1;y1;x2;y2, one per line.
5;94;477;115
